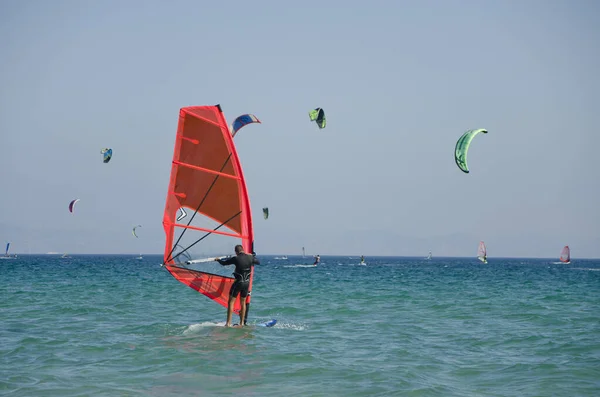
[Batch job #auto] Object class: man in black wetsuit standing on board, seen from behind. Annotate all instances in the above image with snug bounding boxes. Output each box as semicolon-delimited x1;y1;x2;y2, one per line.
215;245;260;327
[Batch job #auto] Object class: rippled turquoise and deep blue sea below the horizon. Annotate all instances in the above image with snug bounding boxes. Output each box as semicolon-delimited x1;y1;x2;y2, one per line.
0;255;600;397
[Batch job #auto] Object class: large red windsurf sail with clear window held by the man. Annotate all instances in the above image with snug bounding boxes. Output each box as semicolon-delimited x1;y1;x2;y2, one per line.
163;105;254;313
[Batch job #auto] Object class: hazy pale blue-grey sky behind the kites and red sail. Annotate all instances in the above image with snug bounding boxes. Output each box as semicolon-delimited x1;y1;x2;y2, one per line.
0;0;600;257
